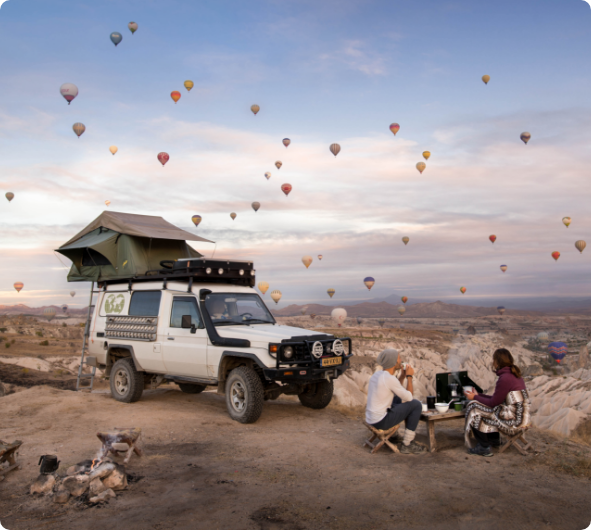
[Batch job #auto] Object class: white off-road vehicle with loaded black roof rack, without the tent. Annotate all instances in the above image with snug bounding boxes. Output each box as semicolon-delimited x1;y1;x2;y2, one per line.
86;258;352;423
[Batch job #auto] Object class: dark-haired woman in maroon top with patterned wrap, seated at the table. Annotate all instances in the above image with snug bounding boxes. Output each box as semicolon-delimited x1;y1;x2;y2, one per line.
465;348;530;457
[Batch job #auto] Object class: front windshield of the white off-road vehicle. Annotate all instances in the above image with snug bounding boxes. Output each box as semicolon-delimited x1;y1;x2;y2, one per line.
205;293;275;326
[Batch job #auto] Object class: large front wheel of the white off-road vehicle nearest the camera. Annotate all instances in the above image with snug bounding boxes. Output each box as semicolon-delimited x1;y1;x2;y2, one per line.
226;366;265;423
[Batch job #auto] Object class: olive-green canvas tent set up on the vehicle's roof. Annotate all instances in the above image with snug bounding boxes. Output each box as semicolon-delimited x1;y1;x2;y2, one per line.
56;212;213;282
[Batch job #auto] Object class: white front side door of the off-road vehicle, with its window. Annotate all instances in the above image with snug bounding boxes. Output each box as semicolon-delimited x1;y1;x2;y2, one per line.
163;295;208;377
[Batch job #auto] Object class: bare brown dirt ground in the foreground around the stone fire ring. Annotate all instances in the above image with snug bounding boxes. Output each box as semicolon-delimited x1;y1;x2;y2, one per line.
0;386;591;530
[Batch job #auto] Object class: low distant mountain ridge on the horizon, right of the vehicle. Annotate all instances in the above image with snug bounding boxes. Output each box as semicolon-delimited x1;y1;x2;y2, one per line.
272;300;544;319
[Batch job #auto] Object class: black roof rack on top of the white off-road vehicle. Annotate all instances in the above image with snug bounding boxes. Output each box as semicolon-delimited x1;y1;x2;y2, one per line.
100;258;255;287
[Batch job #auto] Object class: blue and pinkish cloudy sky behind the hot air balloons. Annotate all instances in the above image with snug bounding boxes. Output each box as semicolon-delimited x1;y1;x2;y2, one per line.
0;0;591;308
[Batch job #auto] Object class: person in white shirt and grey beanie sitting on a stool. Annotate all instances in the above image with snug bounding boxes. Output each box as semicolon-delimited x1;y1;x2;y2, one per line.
365;348;425;454
